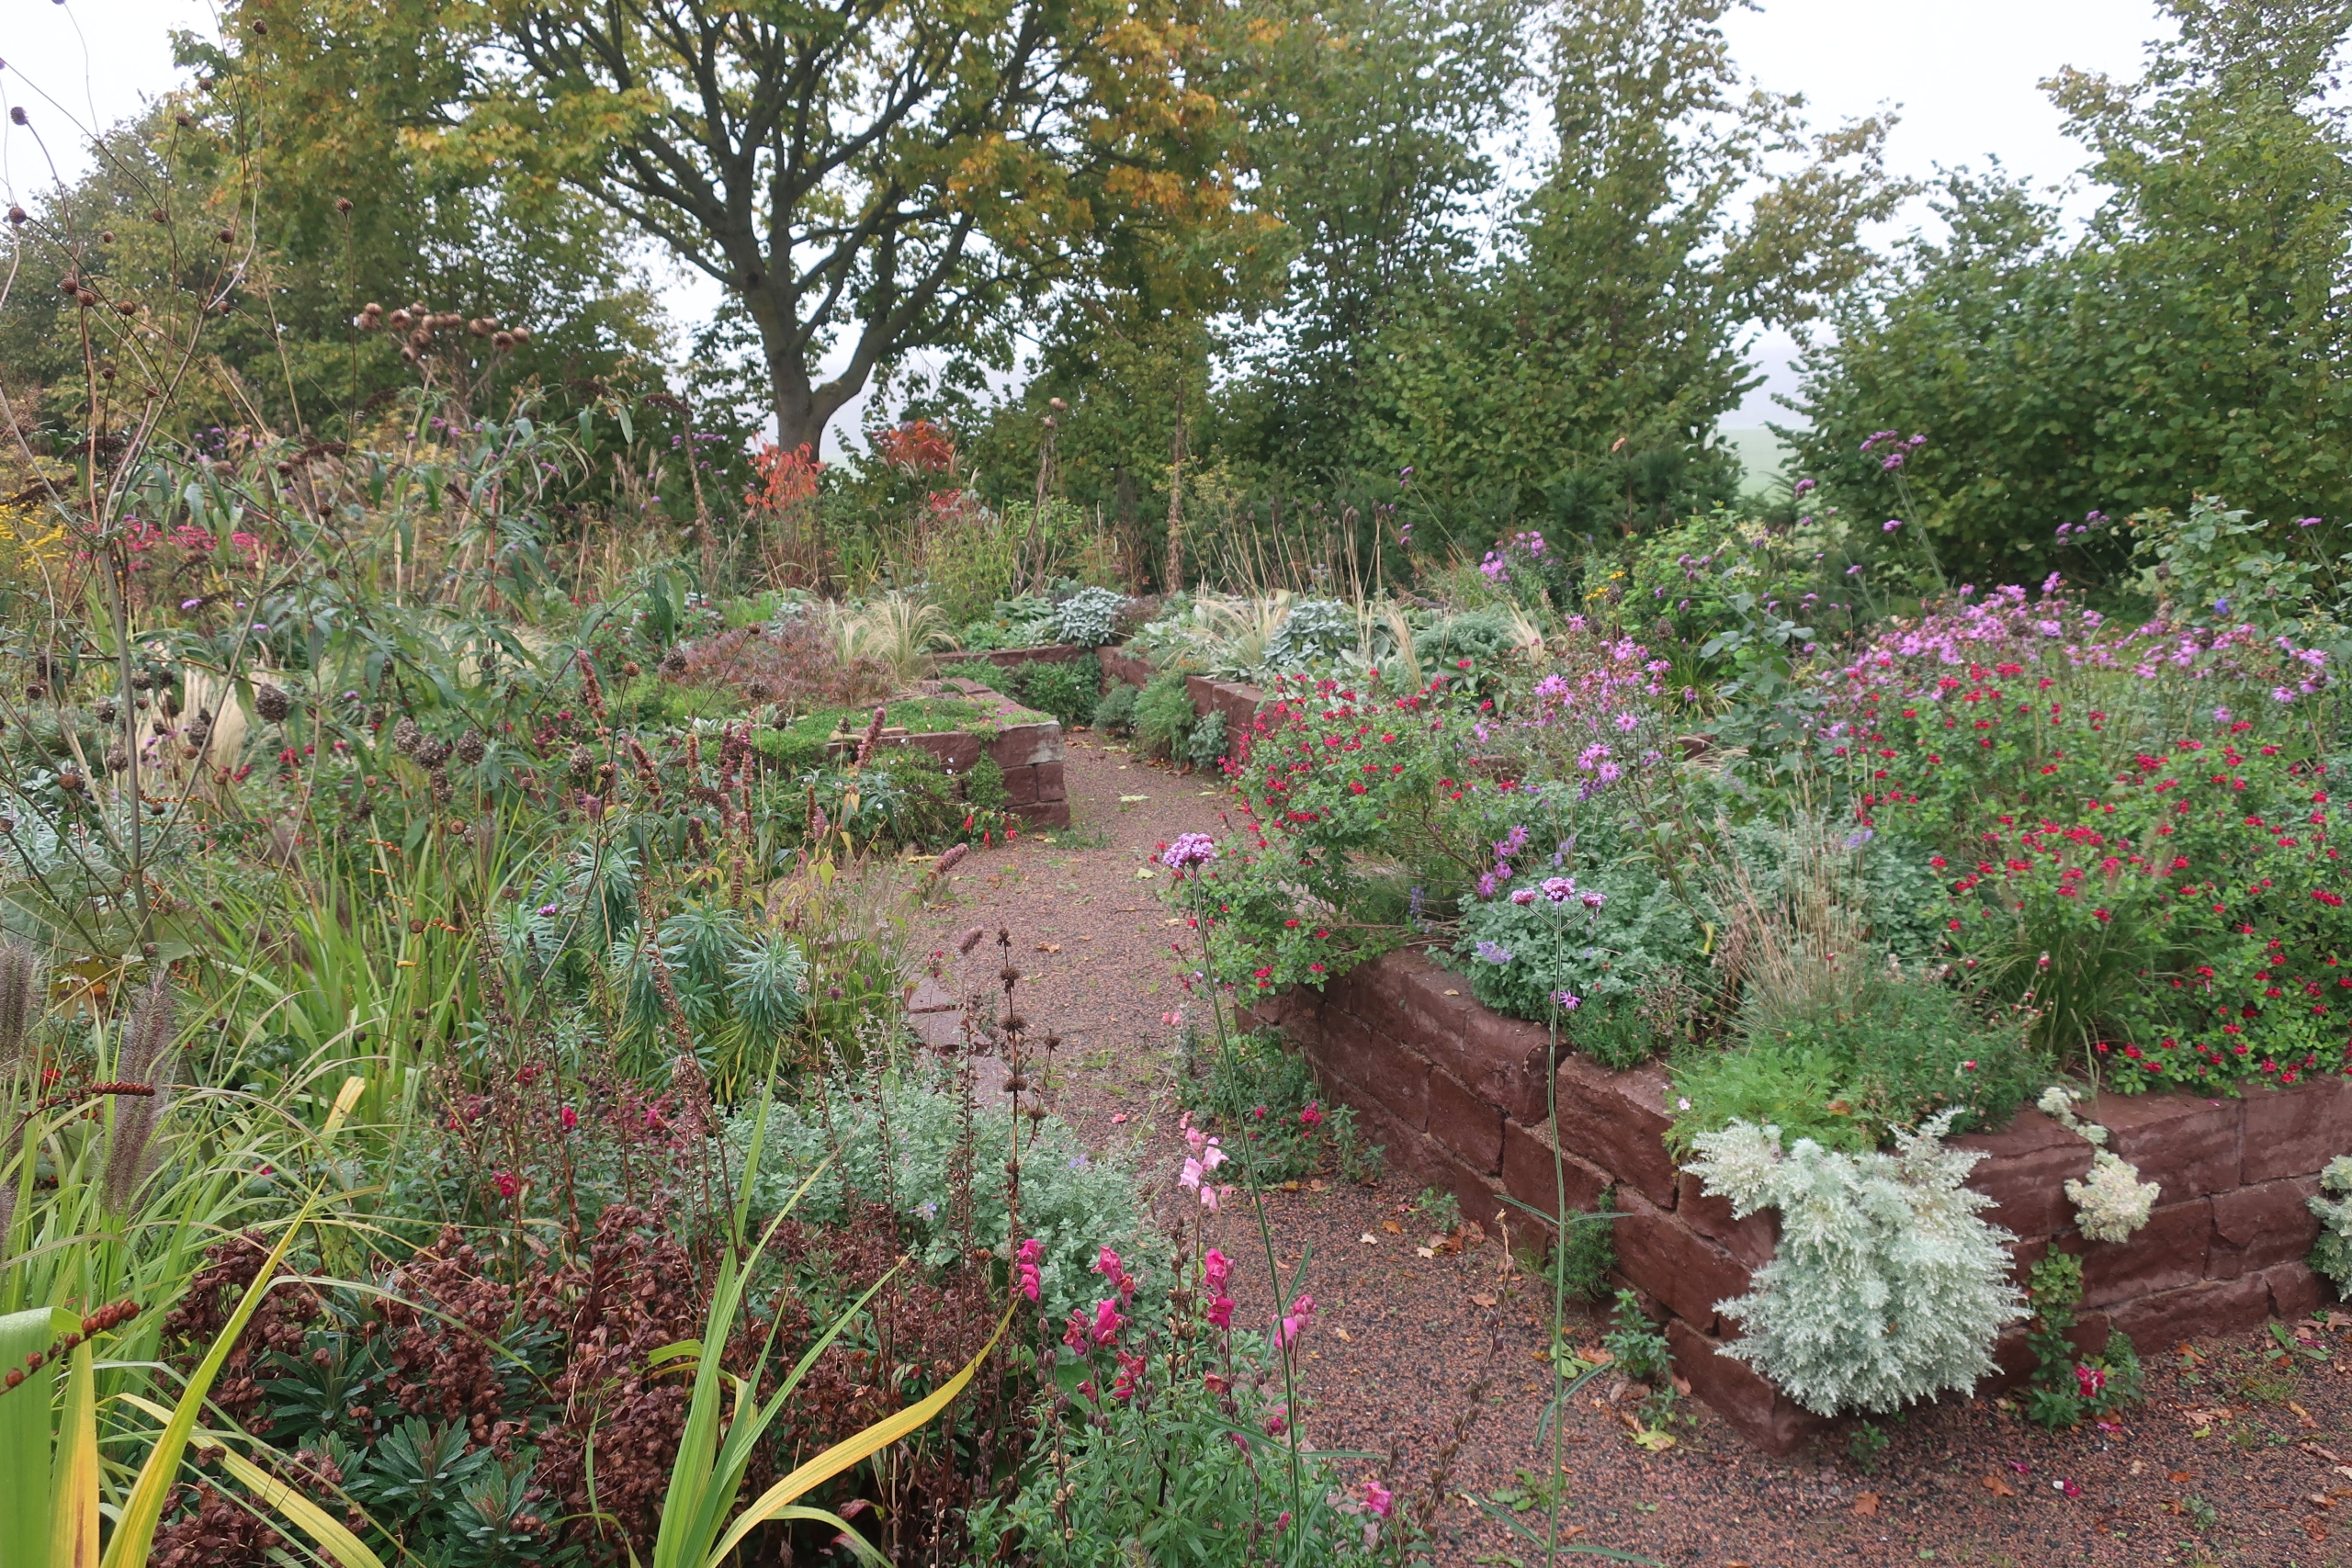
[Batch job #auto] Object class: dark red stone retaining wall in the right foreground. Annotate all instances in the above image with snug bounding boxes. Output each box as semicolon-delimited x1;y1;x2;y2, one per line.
1256;952;2352;1453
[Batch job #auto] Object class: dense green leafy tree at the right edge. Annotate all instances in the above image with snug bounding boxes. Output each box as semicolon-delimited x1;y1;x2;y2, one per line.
1785;0;2352;581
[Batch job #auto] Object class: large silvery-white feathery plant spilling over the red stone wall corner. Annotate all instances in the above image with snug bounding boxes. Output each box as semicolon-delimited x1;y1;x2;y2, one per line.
1689;1112;2025;1416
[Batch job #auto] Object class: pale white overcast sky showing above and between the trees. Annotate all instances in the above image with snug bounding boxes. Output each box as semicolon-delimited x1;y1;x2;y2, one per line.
0;0;2164;442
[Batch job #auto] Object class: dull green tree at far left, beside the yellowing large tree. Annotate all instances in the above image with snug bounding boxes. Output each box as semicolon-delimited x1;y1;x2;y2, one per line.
0;5;659;446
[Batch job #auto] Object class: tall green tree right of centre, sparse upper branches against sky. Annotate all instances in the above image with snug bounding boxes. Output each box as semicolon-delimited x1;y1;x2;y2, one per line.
1360;0;1903;543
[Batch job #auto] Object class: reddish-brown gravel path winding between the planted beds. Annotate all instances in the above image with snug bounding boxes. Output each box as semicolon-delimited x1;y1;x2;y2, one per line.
924;731;2352;1568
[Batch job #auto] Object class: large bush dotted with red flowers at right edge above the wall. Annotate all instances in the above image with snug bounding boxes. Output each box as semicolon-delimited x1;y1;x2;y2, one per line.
1830;579;2352;1093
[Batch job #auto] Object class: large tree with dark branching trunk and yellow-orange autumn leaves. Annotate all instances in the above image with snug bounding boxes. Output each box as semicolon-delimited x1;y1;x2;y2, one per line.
308;0;1232;446
